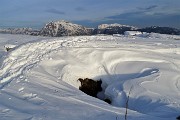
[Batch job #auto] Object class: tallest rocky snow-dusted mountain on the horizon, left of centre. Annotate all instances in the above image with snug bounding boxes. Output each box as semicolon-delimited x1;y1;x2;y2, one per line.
40;20;92;37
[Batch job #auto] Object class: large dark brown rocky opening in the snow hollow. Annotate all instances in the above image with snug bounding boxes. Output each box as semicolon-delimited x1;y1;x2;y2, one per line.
78;78;102;98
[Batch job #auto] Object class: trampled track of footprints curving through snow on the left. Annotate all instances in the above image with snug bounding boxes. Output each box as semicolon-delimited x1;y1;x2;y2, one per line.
0;39;79;88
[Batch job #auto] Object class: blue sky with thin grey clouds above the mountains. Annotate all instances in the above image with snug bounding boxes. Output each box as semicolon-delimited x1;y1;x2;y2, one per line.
0;0;180;28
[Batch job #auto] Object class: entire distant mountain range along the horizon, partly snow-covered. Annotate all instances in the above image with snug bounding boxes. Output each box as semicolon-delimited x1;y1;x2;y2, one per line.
0;20;180;37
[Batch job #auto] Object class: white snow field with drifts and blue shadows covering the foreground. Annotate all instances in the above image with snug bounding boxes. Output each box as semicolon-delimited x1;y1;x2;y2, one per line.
0;33;180;120
